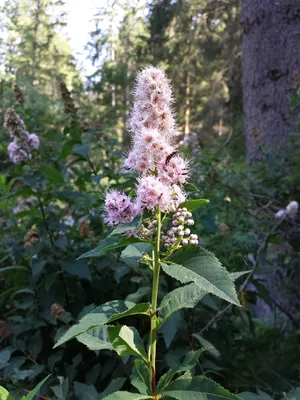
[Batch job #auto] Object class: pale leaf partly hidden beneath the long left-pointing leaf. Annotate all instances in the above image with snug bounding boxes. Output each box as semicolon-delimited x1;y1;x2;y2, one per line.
76;325;114;351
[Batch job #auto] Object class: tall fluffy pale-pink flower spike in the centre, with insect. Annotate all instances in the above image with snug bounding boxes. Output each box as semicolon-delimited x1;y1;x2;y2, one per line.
104;67;189;225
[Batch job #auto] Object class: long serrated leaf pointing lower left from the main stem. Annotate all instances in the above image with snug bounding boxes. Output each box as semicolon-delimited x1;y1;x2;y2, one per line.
54;300;150;348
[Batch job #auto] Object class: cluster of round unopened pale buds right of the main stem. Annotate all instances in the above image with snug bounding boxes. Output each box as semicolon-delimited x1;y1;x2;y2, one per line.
162;208;199;247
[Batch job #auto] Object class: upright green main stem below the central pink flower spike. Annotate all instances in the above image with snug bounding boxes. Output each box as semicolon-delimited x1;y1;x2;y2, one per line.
149;209;161;396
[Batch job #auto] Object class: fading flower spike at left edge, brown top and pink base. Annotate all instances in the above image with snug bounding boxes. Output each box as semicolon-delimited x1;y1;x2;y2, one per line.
4;108;40;164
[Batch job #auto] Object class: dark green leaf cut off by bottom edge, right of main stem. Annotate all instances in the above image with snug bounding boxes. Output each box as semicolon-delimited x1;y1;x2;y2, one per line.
162;376;240;400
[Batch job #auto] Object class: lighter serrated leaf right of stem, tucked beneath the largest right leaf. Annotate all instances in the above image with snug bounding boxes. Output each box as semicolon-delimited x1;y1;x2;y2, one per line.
158;283;207;326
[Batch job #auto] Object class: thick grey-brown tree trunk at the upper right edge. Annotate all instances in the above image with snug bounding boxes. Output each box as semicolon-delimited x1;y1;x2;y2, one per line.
241;0;300;161
